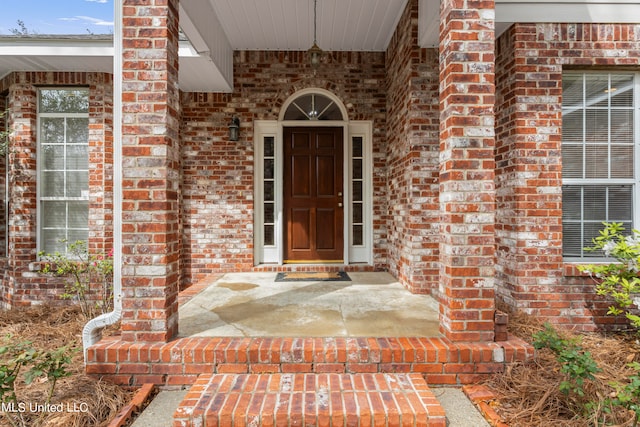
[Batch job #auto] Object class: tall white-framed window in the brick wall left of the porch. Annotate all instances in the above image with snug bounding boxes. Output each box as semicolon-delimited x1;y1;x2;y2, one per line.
38;88;89;253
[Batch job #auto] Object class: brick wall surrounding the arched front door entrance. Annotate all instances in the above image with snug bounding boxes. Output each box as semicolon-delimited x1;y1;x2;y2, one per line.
181;51;387;286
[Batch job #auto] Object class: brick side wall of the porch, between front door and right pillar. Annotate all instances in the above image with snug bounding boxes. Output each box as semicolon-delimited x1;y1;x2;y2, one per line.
387;0;440;293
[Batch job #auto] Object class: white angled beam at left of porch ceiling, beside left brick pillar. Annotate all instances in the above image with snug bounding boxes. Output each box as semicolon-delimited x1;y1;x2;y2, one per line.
179;0;233;91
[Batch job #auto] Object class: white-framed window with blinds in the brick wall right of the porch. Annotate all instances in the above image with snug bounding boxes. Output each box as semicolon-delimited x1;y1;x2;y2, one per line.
562;72;638;259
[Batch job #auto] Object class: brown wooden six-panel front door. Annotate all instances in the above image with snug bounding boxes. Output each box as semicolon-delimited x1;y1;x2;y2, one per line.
283;127;344;262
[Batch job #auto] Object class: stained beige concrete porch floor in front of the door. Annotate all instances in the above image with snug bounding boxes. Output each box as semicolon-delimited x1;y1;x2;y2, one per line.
179;272;440;337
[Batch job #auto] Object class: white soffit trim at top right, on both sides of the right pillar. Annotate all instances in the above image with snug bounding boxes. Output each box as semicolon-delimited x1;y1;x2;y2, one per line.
418;0;640;47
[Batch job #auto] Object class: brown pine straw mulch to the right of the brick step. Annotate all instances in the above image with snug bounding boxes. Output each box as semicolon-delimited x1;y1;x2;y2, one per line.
486;313;640;427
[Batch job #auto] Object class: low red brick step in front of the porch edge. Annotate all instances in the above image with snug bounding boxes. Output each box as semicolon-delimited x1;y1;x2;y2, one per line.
173;373;446;427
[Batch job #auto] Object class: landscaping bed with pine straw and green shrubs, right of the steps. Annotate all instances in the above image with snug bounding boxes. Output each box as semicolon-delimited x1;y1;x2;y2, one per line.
485;313;640;427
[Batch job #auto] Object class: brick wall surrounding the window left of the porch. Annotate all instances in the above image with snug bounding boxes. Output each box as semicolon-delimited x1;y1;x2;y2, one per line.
0;72;112;307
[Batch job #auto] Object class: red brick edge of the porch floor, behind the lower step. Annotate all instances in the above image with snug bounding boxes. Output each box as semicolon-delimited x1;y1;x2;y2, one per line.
86;337;534;386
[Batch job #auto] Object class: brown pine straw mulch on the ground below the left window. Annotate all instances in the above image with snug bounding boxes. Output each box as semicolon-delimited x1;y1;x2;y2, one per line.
0;306;132;427
